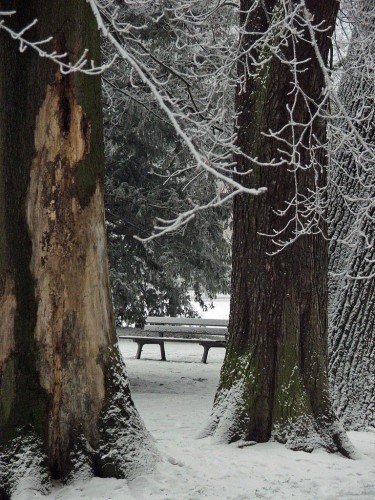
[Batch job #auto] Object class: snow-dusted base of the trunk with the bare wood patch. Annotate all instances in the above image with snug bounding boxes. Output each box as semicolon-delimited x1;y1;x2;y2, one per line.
0;349;161;500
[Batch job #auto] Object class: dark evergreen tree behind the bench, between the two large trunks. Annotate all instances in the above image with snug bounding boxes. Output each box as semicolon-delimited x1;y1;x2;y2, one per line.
105;5;230;325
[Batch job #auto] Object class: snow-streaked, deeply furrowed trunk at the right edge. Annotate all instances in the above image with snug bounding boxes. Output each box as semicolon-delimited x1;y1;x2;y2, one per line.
329;0;375;430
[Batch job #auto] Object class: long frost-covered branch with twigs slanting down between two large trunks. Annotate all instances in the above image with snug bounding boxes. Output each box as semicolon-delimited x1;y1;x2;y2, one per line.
88;0;265;242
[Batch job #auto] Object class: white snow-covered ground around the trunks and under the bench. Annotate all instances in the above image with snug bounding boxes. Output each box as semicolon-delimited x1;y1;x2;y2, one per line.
14;298;375;500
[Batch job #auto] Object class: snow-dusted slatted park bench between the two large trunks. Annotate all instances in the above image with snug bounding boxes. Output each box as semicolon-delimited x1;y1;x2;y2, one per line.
118;316;228;363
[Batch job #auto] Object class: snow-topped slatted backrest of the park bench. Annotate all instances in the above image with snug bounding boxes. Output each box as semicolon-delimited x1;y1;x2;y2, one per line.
144;316;228;336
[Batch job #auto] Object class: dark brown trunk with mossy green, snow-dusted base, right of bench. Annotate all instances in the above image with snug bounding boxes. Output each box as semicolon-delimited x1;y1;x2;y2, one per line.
203;0;352;455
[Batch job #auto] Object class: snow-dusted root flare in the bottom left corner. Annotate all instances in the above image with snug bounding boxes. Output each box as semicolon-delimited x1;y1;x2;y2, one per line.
0;429;50;498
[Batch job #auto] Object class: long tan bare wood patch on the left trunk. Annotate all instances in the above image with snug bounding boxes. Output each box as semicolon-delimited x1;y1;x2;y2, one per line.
26;73;113;468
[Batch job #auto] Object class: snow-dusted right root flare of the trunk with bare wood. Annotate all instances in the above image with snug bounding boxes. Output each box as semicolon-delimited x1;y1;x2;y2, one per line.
98;349;160;480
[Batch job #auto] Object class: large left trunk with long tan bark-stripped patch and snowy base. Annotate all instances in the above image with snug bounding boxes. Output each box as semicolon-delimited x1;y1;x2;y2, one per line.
0;0;156;498
